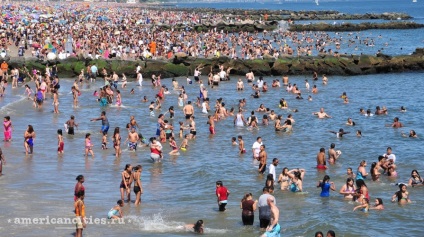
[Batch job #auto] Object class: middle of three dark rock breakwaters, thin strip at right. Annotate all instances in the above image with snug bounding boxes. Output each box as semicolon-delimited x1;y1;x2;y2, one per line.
289;21;424;32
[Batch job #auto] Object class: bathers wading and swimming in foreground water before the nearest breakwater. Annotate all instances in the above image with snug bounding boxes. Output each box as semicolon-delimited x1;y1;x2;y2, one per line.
0;56;424;236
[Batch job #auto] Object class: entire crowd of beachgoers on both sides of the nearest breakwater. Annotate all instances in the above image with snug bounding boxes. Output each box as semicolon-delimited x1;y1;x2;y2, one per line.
0;4;424;237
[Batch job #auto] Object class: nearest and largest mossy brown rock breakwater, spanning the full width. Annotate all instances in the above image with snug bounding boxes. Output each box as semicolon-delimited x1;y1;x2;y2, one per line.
8;48;424;78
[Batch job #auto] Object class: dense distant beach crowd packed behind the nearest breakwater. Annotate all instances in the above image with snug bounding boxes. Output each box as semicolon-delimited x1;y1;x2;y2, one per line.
0;3;388;64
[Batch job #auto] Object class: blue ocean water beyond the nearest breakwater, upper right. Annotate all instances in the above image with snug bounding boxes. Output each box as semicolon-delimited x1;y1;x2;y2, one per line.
177;0;424;55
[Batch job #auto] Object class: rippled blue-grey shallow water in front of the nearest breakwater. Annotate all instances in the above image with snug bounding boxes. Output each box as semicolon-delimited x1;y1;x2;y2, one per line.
0;70;424;236
